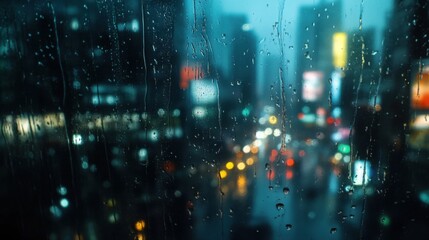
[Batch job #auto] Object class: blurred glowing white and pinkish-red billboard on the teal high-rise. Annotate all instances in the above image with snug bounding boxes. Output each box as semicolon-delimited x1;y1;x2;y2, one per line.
302;71;325;102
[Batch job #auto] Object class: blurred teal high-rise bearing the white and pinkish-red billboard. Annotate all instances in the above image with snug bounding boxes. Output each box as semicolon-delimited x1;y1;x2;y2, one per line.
293;1;341;138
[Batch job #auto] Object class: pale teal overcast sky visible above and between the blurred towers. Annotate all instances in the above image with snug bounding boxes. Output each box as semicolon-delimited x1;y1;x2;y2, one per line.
212;0;392;83
